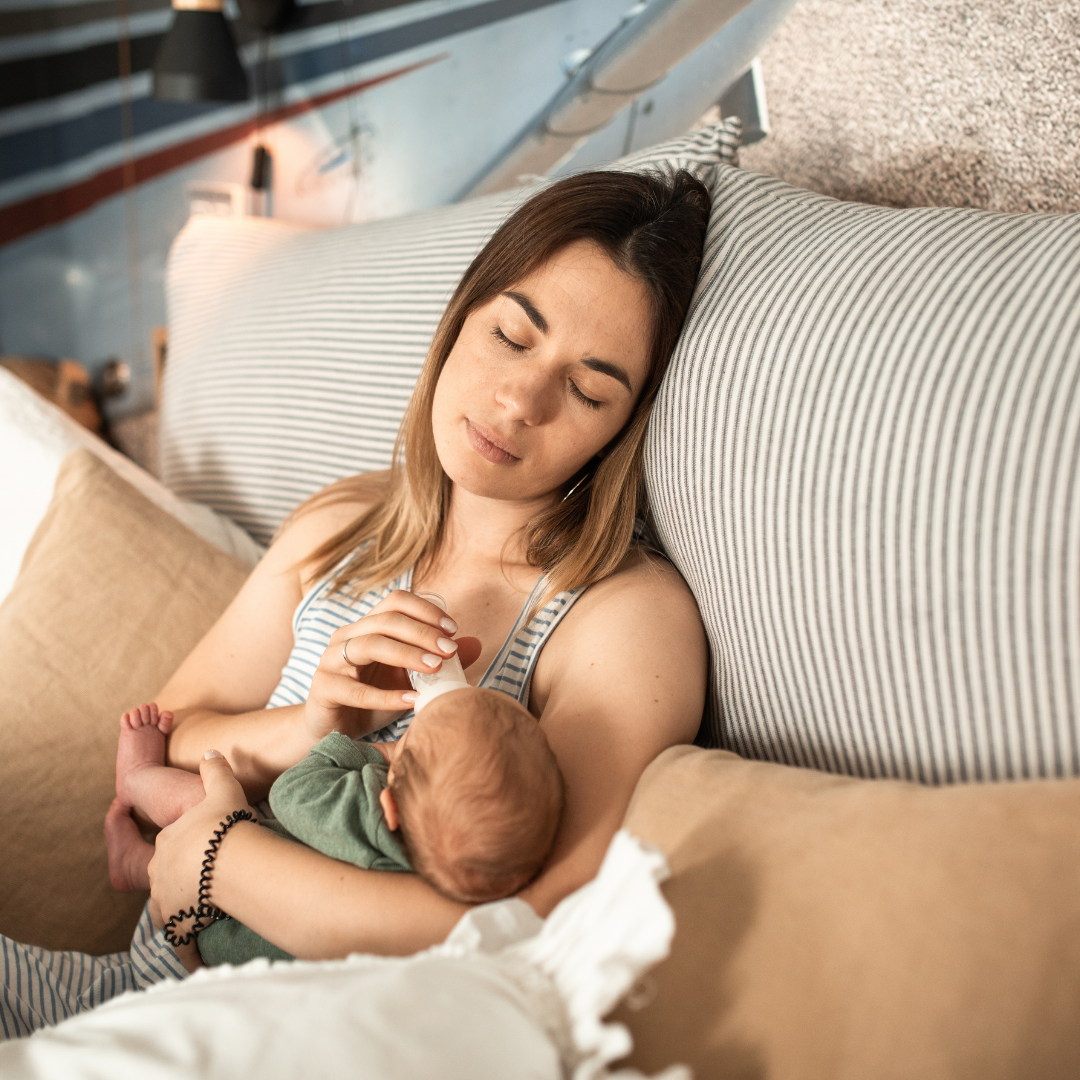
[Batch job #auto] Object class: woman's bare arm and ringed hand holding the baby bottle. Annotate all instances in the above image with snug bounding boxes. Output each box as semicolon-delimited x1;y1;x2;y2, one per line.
158;477;480;799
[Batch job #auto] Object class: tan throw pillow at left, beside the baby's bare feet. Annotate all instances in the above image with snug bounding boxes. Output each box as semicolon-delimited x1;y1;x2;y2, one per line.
0;449;247;954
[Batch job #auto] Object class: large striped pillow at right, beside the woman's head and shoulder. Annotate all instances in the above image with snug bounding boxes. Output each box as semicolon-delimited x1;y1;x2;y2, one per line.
646;167;1080;783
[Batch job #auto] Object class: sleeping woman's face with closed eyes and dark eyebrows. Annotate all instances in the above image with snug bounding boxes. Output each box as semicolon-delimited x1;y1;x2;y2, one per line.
432;241;651;500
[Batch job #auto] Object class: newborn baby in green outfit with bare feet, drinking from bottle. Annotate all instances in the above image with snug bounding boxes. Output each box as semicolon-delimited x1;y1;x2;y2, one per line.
105;689;563;970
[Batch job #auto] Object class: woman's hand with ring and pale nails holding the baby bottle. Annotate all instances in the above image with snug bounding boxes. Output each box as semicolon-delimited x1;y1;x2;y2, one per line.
303;589;481;743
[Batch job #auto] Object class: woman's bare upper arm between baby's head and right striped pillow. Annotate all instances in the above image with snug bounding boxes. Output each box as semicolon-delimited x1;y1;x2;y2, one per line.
522;559;707;916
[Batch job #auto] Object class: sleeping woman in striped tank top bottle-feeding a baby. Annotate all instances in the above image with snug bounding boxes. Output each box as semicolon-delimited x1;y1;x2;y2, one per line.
0;173;708;1036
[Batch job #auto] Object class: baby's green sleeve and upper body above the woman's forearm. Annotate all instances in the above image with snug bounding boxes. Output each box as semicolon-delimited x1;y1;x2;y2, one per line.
270;731;409;870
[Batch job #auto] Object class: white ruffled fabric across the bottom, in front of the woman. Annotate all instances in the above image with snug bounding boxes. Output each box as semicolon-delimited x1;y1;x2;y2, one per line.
0;832;690;1080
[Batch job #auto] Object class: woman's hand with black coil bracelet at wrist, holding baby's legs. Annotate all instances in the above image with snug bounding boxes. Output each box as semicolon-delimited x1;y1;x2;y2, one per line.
148;750;258;932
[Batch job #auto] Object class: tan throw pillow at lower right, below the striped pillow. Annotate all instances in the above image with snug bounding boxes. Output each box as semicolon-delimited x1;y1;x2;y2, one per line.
618;746;1080;1080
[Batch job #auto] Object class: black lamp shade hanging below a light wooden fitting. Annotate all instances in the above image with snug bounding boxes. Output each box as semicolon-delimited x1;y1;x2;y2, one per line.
153;10;249;102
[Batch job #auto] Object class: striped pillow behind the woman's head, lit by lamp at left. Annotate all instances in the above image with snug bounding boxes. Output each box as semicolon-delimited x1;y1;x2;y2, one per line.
160;121;739;543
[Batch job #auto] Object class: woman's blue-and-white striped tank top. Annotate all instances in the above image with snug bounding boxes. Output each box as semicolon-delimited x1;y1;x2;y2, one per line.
267;557;584;742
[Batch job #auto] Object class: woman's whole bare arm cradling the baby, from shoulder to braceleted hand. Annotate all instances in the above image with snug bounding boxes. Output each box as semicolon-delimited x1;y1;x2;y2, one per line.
151;563;705;959
